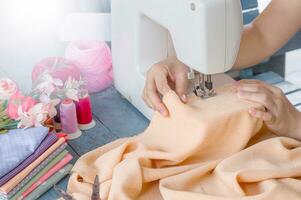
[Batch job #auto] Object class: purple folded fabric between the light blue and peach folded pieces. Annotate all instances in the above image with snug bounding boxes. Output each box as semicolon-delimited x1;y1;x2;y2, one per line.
0;134;58;186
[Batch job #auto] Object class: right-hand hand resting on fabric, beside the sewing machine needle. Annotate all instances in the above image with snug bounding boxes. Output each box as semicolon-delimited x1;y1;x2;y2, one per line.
234;80;301;140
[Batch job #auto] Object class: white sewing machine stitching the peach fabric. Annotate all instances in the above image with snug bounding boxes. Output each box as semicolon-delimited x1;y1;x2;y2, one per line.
111;0;243;118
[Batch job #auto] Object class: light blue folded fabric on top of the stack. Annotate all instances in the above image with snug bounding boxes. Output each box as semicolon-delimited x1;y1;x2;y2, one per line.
0;127;48;178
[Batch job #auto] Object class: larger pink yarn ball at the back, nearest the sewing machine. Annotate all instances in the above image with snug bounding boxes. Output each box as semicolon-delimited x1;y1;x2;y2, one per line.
65;41;113;93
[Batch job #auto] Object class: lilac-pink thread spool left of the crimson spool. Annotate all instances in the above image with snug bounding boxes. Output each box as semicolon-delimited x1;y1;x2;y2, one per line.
60;99;82;140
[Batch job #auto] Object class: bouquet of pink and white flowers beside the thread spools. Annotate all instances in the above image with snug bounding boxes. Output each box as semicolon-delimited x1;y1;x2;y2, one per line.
0;73;83;133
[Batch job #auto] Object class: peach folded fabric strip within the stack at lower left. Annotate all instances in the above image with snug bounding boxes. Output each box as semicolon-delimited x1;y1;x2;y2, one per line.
0;138;65;194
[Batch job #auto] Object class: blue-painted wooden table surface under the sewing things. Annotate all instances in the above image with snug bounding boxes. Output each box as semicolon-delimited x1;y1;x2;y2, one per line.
40;72;301;200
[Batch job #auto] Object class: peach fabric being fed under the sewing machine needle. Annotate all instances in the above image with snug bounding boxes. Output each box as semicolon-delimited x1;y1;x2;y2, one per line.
68;87;301;200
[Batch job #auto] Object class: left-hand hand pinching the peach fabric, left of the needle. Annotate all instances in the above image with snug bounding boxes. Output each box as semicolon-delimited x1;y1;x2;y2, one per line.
143;58;188;117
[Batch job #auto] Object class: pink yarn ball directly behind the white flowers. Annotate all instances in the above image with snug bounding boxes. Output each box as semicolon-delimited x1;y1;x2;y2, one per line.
32;57;81;82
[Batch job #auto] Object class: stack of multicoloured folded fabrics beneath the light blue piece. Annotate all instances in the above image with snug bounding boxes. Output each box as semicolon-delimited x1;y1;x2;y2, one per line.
0;134;72;200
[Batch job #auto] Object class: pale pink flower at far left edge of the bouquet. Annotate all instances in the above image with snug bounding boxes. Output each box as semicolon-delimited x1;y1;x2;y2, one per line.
0;78;18;100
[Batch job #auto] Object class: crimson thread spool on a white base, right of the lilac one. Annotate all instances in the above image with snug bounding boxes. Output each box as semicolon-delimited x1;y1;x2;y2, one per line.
76;90;96;130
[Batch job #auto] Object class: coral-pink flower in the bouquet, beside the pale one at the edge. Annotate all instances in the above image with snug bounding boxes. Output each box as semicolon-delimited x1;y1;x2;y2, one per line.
7;92;36;120
